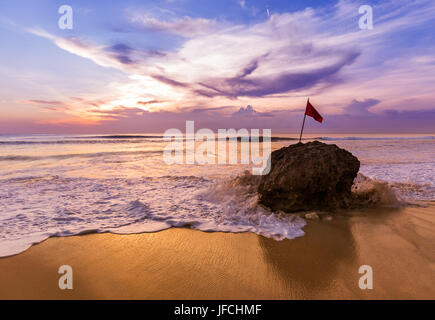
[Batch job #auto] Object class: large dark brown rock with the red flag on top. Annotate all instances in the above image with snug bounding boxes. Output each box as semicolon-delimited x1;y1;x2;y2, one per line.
258;141;360;212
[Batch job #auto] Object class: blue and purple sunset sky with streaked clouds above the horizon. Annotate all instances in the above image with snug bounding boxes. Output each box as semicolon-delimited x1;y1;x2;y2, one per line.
0;0;435;134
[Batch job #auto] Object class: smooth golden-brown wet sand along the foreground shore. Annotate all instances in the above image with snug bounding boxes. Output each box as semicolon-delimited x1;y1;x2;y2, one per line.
0;203;435;299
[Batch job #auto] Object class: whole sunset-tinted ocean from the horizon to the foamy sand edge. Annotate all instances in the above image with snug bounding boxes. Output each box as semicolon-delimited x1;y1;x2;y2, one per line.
0;133;435;257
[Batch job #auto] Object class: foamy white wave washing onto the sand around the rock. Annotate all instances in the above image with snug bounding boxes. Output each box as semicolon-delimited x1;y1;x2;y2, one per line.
0;171;435;256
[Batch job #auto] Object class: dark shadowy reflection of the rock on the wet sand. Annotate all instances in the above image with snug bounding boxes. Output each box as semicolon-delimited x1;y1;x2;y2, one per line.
259;218;357;298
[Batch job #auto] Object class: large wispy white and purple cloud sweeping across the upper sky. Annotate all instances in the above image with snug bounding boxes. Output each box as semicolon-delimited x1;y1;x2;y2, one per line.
28;8;359;99
